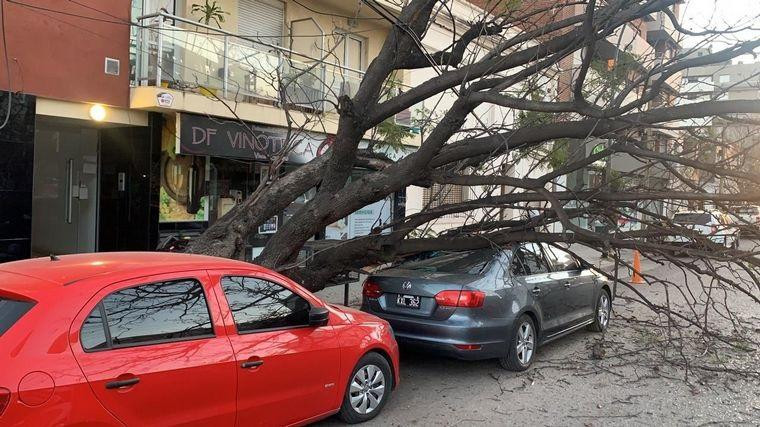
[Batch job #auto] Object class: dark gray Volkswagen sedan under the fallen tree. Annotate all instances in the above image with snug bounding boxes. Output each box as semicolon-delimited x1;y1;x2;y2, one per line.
362;243;612;371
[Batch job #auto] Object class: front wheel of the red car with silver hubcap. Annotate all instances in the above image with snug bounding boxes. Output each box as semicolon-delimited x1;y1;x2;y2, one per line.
338;352;393;424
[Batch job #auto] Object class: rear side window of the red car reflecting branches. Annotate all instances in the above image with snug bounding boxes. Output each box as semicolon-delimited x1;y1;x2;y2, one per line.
80;279;214;350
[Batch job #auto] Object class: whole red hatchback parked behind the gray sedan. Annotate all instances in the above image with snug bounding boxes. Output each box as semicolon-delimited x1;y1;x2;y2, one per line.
0;253;399;426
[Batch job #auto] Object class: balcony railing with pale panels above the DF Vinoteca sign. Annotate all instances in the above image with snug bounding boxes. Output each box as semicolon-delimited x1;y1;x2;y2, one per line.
133;12;422;126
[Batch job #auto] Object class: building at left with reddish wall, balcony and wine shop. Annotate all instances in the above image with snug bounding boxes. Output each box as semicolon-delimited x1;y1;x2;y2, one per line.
0;0;416;260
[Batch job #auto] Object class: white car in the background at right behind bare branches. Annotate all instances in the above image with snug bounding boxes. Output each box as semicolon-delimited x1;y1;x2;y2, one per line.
664;211;740;248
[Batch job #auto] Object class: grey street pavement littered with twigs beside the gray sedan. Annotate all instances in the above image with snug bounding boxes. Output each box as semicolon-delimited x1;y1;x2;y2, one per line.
318;242;760;426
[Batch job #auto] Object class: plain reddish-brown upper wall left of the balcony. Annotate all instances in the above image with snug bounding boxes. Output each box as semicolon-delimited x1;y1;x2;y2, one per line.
0;0;131;107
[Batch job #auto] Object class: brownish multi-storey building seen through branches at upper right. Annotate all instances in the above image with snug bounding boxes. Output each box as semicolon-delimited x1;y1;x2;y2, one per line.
510;1;682;229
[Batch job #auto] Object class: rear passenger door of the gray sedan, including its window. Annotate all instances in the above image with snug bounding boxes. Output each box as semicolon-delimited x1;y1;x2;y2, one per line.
511;243;565;335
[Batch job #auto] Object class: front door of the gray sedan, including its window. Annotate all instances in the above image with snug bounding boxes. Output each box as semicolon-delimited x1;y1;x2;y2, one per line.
543;245;596;326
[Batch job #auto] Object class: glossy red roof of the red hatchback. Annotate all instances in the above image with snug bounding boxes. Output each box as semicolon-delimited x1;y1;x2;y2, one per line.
0;252;263;286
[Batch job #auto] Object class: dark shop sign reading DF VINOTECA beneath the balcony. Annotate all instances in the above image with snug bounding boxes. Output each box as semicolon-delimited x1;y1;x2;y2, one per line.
179;113;286;160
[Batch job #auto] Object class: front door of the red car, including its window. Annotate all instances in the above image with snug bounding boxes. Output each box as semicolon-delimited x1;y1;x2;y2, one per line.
206;271;343;426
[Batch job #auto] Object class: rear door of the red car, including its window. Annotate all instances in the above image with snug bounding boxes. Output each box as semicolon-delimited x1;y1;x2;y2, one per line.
69;271;237;426
